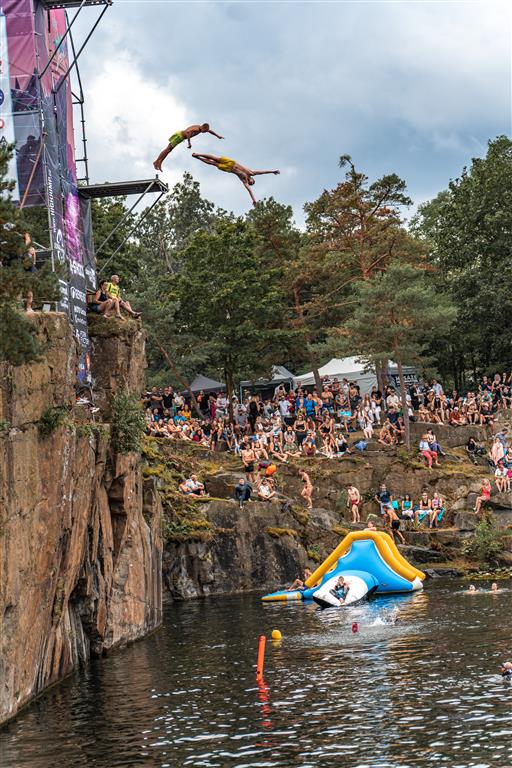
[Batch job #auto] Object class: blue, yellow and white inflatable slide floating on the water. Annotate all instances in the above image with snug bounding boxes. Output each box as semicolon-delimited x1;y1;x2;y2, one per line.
262;531;425;607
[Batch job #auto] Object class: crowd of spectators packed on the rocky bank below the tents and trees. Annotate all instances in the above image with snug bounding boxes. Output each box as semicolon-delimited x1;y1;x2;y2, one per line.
143;374;512;520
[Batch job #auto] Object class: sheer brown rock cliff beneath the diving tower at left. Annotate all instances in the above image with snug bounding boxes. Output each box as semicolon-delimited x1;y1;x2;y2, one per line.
0;314;162;722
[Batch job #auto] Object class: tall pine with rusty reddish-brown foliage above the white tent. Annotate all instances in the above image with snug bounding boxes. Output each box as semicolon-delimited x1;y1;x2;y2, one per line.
306;155;425;385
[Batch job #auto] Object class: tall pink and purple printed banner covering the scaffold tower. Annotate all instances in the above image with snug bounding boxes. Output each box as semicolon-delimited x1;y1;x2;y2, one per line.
0;0;94;384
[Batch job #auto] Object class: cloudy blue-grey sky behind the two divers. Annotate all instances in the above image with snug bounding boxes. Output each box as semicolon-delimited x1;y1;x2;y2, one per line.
76;0;512;222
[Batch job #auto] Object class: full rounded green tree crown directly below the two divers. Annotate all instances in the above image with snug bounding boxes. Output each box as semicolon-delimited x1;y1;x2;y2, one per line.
173;219;286;402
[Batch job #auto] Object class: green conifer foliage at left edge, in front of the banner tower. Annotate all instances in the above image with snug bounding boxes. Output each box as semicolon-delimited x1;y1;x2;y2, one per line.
0;147;58;365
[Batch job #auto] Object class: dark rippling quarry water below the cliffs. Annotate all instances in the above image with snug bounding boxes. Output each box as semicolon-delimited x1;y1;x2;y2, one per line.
0;581;512;768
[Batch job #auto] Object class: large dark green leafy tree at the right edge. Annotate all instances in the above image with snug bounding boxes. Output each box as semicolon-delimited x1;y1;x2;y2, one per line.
412;136;512;386
